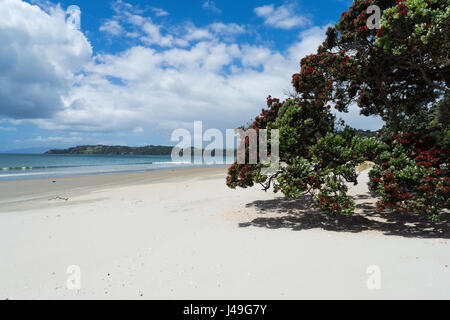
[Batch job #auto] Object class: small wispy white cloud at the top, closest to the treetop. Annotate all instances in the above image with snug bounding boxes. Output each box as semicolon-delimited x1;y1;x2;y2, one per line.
254;4;309;29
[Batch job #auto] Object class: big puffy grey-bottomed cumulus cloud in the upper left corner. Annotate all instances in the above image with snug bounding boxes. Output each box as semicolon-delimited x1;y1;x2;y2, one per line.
0;0;92;119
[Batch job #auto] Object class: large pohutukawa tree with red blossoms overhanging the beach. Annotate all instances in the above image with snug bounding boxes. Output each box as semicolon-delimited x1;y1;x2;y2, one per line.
227;0;450;216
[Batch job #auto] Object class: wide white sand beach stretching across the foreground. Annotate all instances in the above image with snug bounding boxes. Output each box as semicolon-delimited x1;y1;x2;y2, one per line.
0;167;450;299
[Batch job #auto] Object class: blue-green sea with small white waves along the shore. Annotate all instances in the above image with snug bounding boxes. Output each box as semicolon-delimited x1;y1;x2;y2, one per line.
0;154;220;181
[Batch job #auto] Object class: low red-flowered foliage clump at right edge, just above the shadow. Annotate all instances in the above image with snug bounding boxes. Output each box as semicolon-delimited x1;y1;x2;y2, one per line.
369;132;450;216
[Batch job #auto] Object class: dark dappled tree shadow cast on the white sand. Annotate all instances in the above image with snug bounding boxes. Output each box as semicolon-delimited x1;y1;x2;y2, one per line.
239;195;450;239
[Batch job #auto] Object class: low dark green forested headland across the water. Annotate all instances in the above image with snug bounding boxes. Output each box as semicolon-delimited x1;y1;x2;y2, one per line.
45;145;180;155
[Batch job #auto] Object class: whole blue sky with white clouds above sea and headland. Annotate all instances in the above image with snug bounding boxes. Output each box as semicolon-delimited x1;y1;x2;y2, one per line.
0;0;382;151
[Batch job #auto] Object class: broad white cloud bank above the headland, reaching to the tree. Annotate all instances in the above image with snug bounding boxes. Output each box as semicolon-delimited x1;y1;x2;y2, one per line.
34;28;324;132
